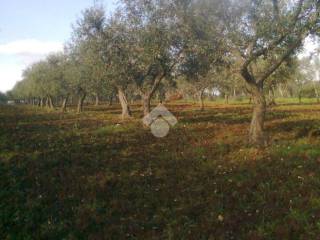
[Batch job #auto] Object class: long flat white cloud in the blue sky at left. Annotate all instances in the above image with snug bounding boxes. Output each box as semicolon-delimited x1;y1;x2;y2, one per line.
0;39;63;55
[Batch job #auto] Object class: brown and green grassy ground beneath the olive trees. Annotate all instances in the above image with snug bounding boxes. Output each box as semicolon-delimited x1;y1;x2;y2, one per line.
0;102;320;240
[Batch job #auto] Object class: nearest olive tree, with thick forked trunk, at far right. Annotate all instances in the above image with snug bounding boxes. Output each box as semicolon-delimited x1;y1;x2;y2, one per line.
223;0;320;145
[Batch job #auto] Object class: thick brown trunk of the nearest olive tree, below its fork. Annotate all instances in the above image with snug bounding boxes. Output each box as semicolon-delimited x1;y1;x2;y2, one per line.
249;86;266;146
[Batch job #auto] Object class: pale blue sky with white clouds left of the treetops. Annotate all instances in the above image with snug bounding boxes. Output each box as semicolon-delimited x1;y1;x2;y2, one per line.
0;0;115;92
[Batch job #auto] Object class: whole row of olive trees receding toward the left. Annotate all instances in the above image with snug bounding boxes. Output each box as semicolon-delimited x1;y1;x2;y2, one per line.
9;0;320;145
